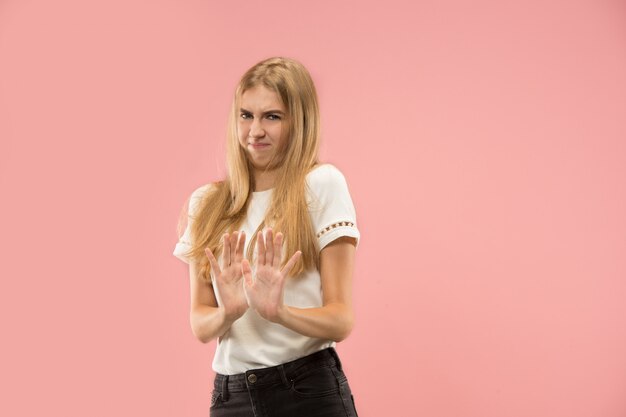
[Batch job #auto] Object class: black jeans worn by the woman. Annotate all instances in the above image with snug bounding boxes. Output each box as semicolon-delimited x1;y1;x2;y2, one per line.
210;347;357;417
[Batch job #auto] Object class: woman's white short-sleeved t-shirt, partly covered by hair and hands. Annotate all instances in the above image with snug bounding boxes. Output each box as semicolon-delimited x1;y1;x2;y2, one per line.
173;164;360;375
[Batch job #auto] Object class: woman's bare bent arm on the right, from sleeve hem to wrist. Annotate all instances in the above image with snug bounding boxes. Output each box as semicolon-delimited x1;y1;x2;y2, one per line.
272;237;356;342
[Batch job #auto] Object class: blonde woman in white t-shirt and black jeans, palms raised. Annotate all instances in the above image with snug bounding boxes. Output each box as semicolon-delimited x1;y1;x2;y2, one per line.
174;57;360;417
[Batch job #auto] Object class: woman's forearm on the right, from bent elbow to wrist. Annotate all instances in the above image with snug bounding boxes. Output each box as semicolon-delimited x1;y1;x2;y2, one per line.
272;303;354;342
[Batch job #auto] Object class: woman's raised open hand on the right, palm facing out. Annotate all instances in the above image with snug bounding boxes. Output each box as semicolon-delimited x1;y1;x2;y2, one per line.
241;229;302;321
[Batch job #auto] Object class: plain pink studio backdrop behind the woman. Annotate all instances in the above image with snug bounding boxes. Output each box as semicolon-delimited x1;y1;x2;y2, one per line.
0;0;626;417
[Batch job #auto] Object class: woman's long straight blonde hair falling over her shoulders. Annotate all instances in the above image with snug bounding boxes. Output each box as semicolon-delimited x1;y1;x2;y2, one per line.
181;57;320;280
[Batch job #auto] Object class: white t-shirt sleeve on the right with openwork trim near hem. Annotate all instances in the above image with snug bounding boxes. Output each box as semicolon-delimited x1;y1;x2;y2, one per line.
307;164;361;250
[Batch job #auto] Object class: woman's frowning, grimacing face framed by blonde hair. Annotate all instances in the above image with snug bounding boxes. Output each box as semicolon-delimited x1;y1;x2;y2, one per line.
237;85;288;169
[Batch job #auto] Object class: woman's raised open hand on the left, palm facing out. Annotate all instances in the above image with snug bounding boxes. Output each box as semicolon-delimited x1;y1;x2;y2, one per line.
204;231;248;321
